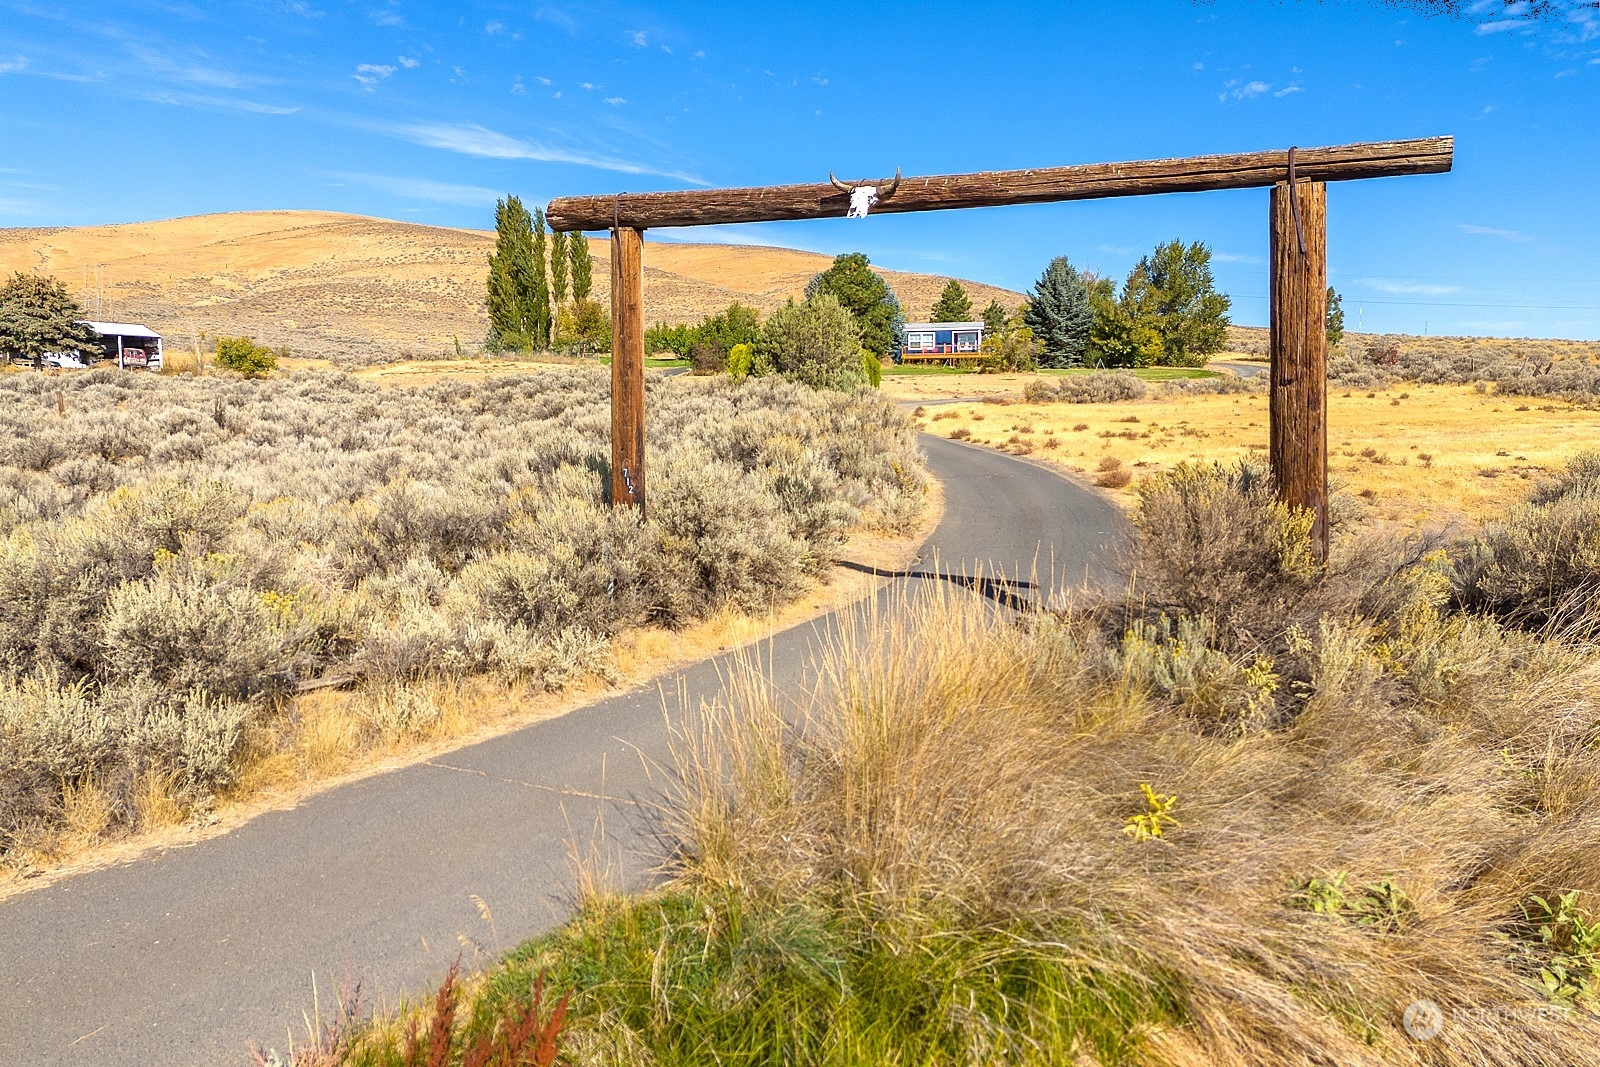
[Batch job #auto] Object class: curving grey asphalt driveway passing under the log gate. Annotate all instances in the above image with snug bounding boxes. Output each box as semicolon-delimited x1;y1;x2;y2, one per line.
0;435;1122;1067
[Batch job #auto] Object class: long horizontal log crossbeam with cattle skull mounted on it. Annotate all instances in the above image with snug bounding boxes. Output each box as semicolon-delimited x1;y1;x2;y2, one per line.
546;138;1454;232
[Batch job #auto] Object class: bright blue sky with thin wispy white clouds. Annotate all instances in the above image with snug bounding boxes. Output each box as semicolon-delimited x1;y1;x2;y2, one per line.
0;0;1600;338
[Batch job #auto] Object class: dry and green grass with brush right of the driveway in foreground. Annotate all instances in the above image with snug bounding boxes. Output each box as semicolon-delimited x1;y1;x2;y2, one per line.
300;466;1600;1067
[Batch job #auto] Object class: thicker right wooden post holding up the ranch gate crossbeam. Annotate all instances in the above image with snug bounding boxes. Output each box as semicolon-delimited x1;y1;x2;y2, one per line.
1269;175;1328;561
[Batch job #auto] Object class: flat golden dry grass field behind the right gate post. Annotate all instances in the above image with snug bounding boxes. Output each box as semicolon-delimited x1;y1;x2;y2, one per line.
918;386;1600;525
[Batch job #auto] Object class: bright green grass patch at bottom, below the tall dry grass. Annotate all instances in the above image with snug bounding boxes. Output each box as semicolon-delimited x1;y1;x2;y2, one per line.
346;891;1181;1067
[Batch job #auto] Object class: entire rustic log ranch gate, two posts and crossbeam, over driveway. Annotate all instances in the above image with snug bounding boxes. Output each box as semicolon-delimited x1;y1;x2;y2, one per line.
546;138;1454;558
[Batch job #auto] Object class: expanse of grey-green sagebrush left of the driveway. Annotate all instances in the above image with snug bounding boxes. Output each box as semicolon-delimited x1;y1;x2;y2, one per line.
0;367;926;854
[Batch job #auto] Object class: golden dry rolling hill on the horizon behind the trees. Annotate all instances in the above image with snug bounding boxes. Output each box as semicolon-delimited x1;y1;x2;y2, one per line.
0;211;1021;363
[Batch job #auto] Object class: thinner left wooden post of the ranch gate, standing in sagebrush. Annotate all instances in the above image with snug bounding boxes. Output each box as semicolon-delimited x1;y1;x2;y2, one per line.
604;226;645;510
